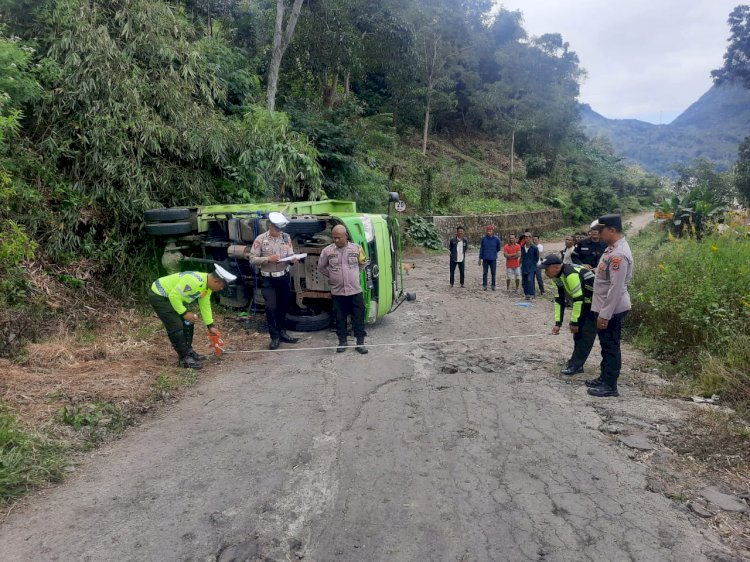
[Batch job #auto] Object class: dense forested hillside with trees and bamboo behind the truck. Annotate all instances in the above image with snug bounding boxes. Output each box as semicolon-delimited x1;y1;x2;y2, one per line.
0;0;659;294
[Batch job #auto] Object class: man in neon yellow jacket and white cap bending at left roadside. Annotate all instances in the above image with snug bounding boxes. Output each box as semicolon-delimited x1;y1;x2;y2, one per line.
148;265;237;370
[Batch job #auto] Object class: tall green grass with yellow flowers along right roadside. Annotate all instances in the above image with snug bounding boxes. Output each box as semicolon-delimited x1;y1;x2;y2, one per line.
629;225;750;416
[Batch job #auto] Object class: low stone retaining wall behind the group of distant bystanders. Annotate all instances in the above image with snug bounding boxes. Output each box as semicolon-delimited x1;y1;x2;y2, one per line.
428;209;565;245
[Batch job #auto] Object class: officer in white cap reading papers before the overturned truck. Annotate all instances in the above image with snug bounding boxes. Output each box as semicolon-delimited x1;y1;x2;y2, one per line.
250;213;299;350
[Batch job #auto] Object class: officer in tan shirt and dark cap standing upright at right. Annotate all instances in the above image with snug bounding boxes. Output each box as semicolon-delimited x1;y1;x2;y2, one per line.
586;215;633;397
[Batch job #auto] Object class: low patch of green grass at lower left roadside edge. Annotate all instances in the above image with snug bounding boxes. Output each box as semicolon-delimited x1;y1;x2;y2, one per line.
0;403;67;506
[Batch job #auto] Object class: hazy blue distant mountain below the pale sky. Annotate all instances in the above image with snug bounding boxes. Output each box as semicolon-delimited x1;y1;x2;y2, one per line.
581;85;750;175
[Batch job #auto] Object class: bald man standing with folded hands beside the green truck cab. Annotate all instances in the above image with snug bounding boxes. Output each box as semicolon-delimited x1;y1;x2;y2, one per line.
318;225;367;354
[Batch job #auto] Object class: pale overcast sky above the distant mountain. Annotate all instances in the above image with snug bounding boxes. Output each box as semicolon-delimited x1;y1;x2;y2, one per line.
496;0;748;124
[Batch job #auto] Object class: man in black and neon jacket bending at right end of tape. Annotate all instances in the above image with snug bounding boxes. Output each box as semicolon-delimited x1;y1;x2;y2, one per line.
540;254;596;376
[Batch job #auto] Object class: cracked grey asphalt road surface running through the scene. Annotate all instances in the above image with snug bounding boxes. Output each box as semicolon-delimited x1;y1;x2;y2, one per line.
0;247;731;562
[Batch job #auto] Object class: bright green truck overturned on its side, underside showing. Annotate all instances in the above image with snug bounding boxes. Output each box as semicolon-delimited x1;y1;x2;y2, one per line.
144;200;414;331
